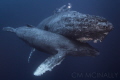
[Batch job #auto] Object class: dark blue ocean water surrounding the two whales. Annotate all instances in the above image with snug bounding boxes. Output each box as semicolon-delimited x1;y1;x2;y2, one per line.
0;0;120;80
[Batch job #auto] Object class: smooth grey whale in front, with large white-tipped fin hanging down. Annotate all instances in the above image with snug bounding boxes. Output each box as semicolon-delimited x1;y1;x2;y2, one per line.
3;26;99;76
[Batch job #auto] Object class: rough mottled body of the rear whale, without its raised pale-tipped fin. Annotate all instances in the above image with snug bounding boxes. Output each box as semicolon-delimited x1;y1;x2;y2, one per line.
37;10;113;40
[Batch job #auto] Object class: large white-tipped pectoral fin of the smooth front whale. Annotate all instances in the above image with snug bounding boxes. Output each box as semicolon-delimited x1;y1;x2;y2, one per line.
34;51;66;76
